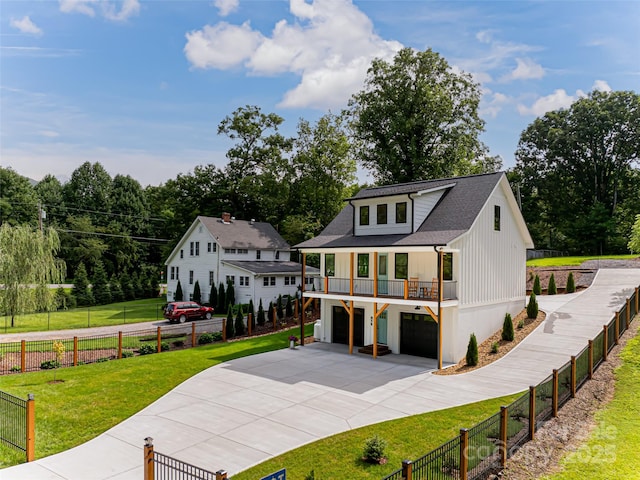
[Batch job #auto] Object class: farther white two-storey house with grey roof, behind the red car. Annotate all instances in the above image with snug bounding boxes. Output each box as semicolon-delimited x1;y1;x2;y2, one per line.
165;213;319;309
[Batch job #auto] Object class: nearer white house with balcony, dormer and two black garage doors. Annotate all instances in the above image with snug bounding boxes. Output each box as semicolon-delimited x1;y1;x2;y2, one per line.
296;173;533;366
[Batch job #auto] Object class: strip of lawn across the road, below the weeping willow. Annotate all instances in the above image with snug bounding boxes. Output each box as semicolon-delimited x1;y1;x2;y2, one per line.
0;298;165;333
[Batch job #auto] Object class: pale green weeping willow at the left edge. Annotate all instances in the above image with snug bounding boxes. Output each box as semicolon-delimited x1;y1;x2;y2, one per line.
0;223;65;327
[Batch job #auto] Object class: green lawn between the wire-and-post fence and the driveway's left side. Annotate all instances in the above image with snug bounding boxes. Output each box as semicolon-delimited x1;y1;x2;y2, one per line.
0;324;313;467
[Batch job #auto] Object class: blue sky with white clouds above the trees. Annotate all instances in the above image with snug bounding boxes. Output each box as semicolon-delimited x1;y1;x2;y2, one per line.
0;0;640;186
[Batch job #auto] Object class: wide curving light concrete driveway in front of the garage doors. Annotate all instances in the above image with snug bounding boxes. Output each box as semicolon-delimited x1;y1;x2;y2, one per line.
0;269;640;480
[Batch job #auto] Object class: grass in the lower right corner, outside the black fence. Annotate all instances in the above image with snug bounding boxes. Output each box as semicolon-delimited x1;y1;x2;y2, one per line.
544;327;640;480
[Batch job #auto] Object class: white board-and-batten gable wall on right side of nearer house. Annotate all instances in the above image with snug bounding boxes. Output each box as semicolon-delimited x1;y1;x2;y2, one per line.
451;182;526;307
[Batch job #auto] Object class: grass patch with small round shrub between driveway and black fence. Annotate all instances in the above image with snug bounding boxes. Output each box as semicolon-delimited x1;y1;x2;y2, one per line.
233;393;522;480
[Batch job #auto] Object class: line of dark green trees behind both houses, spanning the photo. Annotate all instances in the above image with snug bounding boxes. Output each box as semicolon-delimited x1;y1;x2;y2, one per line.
0;48;640;300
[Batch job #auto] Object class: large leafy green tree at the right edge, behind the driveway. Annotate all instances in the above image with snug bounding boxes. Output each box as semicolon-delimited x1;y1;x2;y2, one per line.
510;91;640;254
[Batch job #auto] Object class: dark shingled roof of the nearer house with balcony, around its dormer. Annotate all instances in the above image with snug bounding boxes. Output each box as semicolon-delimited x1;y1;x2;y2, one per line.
295;172;504;249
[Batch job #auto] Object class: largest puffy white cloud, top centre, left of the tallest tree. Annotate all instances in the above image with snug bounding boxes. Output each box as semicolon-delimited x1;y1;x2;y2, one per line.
184;0;402;109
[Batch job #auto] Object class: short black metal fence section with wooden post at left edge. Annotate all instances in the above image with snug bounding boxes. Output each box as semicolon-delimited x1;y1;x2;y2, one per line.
0;391;35;462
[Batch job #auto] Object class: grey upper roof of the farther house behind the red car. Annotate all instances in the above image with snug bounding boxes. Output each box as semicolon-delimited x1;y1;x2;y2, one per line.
198;217;291;250
